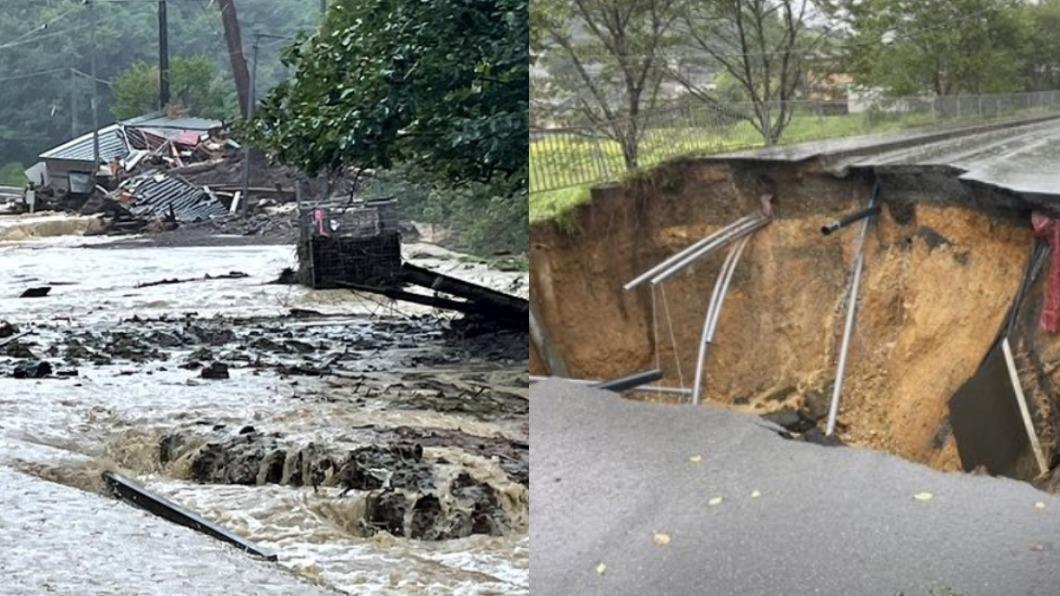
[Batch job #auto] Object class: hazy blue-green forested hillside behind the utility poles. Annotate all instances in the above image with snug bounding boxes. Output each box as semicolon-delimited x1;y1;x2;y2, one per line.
0;0;320;163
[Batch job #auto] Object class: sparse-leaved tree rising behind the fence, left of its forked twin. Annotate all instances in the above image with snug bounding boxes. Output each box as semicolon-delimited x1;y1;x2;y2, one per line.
531;0;682;170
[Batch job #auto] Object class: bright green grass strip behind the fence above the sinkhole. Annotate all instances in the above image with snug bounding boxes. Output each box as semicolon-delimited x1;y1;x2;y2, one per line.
530;104;1034;224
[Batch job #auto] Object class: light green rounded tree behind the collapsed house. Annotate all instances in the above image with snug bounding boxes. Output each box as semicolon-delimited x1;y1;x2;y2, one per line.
110;56;234;120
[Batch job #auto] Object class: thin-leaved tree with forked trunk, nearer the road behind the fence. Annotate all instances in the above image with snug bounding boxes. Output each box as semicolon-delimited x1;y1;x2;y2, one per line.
670;0;828;145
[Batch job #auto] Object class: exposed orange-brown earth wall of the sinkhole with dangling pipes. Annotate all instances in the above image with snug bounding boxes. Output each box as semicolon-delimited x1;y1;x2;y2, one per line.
531;160;1058;470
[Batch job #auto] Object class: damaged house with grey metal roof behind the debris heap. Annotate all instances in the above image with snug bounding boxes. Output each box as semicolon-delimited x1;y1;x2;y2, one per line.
25;113;224;194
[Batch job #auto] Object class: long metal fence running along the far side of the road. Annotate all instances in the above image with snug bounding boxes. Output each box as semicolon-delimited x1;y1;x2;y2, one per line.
530;91;1060;193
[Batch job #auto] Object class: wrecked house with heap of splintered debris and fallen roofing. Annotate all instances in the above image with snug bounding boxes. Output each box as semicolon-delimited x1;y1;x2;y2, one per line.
25;113;303;233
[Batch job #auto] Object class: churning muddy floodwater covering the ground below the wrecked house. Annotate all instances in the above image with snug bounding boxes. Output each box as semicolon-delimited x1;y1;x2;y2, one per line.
0;217;529;594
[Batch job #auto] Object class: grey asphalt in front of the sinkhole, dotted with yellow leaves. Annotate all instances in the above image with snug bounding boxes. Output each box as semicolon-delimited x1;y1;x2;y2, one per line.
530;381;1060;596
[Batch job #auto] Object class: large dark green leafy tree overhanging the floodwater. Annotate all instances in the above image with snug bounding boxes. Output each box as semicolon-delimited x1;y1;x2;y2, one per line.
247;0;529;195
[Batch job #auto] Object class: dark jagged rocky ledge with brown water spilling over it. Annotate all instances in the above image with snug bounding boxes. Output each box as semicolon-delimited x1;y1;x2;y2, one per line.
158;426;511;540
